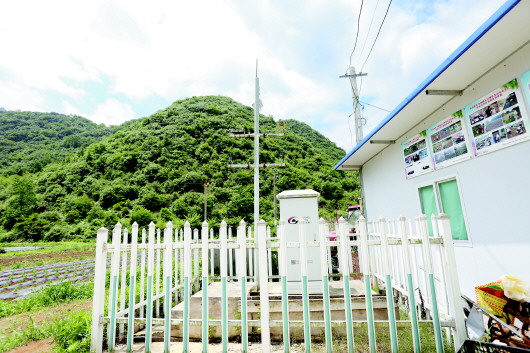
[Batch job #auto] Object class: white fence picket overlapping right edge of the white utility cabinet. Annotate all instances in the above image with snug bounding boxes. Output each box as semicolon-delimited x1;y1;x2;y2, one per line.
318;218;332;353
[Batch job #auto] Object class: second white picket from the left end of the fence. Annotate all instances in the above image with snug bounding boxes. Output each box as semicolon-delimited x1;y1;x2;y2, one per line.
108;222;121;351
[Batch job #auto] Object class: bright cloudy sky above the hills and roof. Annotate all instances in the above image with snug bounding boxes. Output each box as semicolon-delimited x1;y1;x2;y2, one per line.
0;0;504;152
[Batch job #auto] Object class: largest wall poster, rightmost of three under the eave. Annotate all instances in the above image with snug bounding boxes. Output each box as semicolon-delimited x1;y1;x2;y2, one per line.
464;79;529;156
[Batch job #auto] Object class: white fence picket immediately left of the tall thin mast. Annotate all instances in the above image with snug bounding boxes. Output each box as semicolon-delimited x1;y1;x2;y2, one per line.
237;220;248;353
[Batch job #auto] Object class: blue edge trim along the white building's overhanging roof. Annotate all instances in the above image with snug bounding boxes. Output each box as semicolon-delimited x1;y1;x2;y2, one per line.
333;0;521;170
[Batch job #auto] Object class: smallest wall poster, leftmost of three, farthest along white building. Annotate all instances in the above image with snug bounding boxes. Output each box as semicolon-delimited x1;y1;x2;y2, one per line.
401;130;428;179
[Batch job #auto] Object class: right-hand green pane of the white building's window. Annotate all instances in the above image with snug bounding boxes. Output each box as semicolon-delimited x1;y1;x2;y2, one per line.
438;179;468;240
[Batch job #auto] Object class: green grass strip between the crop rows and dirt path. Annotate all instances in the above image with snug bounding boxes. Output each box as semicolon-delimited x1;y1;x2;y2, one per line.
0;282;94;318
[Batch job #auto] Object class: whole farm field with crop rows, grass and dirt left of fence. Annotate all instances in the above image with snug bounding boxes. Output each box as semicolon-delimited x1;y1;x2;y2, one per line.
0;242;95;353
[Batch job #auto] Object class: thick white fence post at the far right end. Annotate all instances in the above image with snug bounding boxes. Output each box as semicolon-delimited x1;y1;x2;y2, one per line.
438;213;467;351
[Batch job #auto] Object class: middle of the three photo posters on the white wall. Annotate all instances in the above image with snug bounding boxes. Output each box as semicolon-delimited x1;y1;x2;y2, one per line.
427;110;471;169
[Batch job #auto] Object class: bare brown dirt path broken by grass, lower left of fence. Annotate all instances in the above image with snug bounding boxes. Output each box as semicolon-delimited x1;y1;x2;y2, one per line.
0;300;92;353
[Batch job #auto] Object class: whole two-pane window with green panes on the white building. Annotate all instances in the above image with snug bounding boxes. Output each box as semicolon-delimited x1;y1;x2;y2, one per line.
418;179;469;241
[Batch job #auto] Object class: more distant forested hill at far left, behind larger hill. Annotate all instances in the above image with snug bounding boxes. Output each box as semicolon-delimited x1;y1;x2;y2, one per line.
0;111;119;175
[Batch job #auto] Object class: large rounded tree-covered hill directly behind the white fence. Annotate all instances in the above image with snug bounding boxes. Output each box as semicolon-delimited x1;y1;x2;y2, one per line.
0;96;359;240
